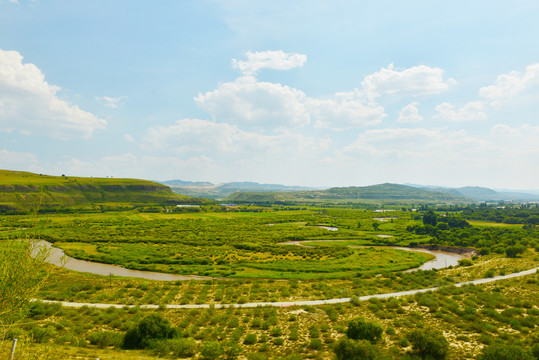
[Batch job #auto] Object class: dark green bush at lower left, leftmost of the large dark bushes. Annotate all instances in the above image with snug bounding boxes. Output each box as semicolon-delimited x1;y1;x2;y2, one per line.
123;314;175;349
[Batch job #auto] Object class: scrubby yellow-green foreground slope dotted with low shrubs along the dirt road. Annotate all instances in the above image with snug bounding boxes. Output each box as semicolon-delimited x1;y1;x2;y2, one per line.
0;252;539;360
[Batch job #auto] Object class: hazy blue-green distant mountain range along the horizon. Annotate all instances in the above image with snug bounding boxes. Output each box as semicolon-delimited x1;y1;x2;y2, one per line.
160;180;539;203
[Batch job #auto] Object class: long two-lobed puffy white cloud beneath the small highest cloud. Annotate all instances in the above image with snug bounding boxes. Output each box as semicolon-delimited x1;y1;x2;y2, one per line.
195;76;386;130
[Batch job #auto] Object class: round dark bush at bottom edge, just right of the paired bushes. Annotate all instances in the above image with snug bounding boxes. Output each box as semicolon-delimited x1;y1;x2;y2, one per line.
407;328;449;360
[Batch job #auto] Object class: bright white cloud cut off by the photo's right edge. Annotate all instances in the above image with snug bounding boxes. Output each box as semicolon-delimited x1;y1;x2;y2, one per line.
479;63;539;100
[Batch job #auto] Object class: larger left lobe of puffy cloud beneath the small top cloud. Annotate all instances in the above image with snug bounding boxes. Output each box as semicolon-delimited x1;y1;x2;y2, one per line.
195;76;310;127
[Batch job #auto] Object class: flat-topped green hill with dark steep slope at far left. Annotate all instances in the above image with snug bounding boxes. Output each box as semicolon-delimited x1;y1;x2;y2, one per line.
0;170;207;211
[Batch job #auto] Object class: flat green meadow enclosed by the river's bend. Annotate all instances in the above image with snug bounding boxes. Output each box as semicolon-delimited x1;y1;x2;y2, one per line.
0;208;432;279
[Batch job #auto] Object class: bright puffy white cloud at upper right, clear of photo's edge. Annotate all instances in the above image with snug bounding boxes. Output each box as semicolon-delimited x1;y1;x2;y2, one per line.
361;64;456;99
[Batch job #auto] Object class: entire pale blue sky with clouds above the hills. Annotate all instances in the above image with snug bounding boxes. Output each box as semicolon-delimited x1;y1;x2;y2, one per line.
0;0;539;189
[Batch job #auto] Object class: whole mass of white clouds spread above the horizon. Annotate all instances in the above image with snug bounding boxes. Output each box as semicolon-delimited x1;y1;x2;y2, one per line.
0;50;539;190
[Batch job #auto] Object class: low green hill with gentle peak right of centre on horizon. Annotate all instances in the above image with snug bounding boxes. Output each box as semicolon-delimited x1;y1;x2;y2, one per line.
227;183;470;204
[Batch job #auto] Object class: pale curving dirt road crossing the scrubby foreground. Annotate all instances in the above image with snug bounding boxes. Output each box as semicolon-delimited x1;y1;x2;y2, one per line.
40;267;539;309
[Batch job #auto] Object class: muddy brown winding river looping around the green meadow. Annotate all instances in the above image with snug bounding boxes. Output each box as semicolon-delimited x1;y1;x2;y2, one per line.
41;240;464;281
